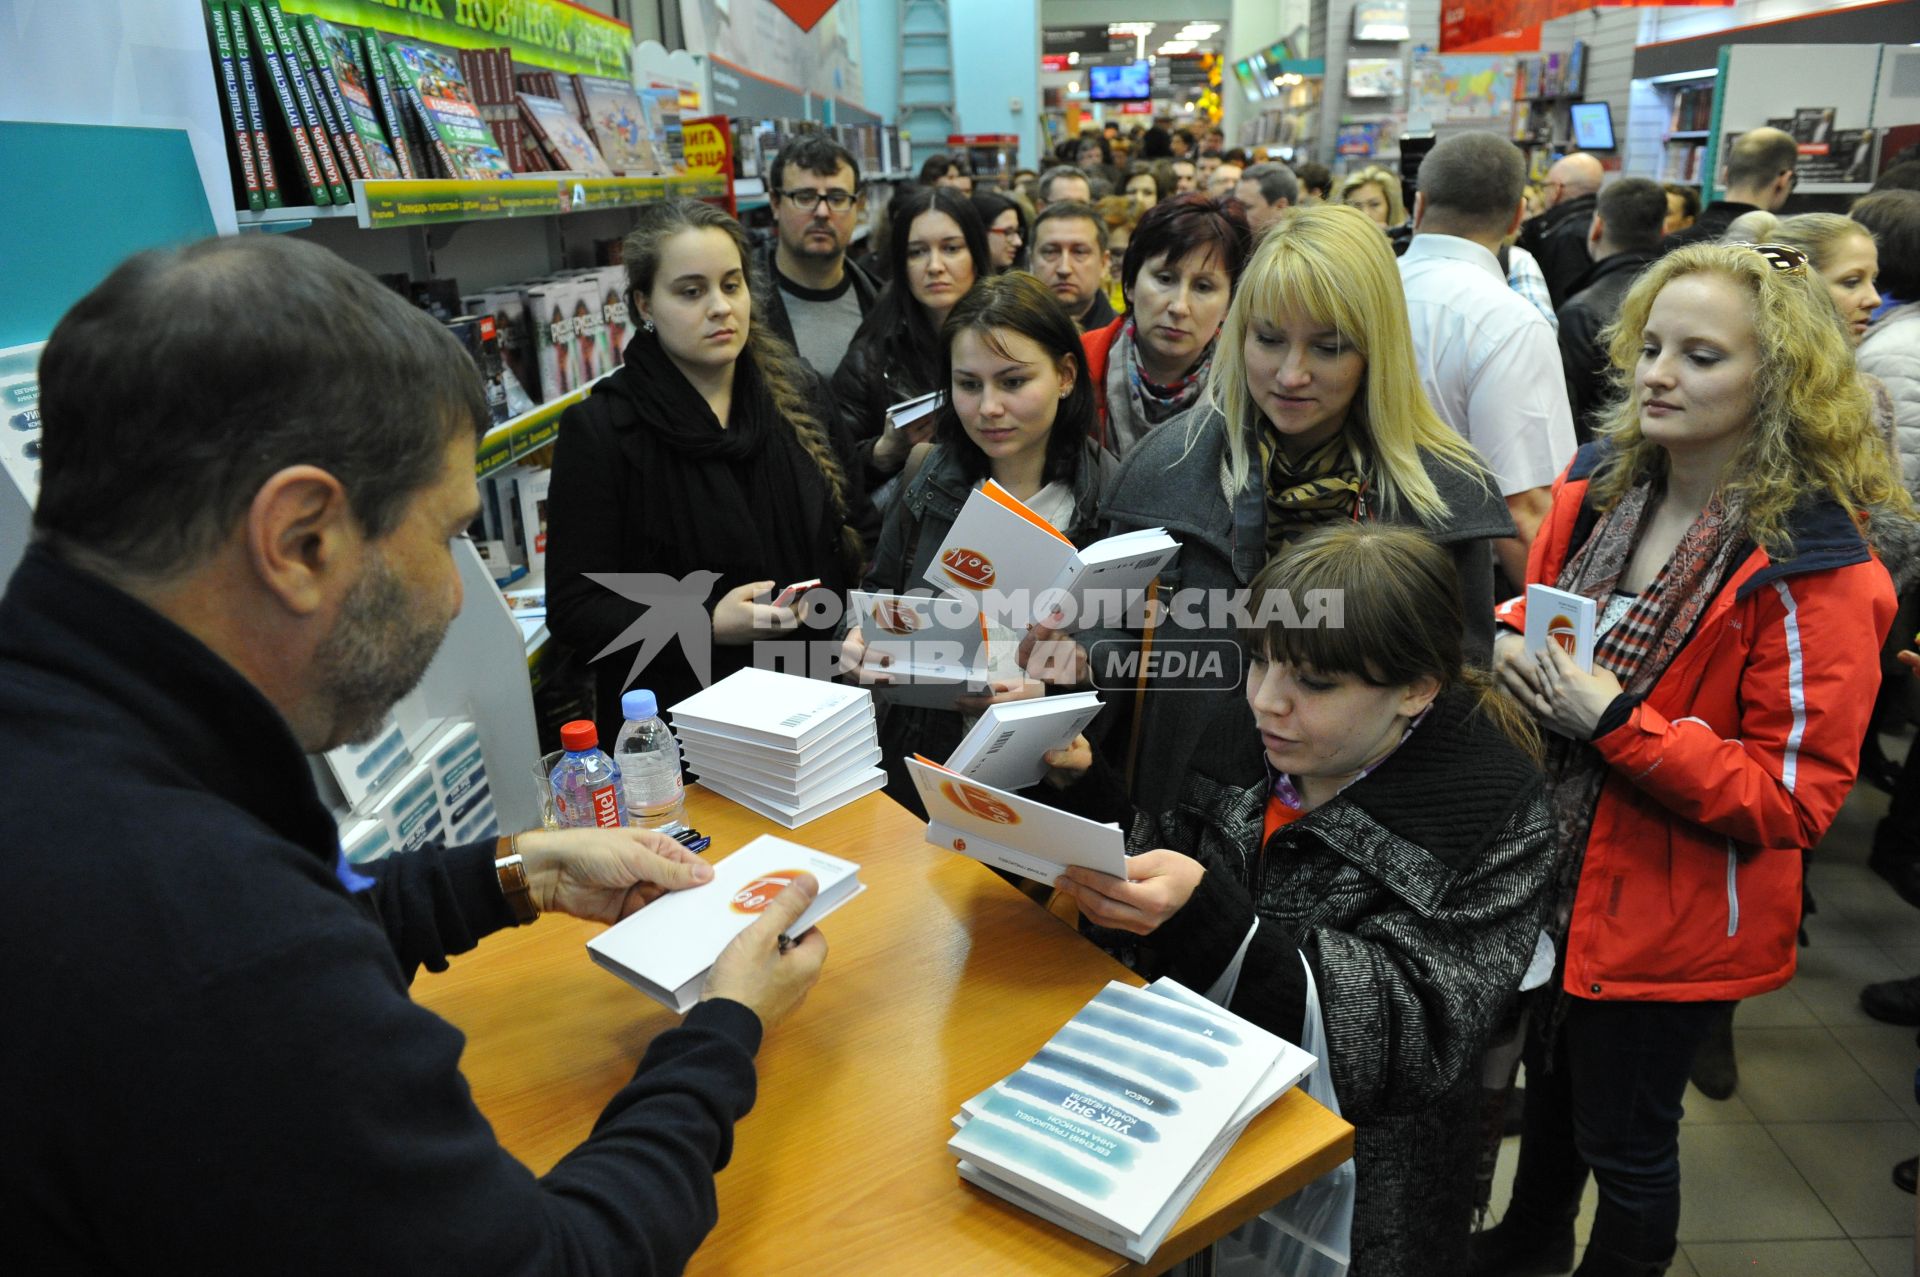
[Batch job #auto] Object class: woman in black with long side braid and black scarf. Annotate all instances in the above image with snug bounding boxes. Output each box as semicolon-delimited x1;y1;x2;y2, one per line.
547;200;872;747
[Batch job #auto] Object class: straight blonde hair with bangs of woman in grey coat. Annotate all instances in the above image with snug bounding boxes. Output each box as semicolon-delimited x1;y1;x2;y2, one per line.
1188;204;1492;526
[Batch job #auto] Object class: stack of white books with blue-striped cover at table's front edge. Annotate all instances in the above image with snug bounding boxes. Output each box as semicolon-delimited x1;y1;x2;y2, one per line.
947;979;1317;1264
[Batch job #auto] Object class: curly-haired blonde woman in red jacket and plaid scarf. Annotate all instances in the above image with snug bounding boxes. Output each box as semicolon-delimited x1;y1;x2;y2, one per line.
1473;246;1910;1277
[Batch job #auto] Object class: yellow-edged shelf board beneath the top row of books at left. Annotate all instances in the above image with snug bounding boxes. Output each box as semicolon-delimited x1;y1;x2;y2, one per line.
236;175;728;230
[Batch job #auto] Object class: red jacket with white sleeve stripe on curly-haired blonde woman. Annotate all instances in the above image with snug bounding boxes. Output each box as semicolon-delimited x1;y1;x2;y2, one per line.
1498;444;1895;1002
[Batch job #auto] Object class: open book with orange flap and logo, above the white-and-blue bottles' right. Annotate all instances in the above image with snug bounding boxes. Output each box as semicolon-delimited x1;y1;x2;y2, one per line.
927;478;1179;630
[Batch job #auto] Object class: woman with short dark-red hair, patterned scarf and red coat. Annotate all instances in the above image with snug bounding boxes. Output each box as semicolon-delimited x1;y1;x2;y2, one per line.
1081;194;1254;457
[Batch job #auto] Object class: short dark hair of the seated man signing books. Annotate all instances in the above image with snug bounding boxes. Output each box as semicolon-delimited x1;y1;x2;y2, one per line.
33;234;492;580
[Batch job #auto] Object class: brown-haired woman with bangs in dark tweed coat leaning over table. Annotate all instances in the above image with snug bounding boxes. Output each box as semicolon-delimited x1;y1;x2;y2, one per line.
1041;522;1553;1277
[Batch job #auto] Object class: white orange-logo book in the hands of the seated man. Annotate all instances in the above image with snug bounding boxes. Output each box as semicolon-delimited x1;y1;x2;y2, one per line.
588;833;866;1012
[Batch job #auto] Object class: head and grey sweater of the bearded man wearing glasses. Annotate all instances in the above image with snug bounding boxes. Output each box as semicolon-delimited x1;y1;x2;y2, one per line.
762;133;879;380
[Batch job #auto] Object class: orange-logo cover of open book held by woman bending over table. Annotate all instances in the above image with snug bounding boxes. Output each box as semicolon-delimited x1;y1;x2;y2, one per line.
906;755;1127;883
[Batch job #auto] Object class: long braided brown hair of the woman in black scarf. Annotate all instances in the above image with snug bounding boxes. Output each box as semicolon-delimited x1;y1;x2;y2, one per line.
620;200;866;563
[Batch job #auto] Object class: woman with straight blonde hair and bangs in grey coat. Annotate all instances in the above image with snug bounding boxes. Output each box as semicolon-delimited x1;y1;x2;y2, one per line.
1083;204;1513;810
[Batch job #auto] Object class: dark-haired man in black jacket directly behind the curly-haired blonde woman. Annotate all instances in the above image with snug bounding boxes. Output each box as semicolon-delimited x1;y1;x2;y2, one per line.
1557;177;1667;444
